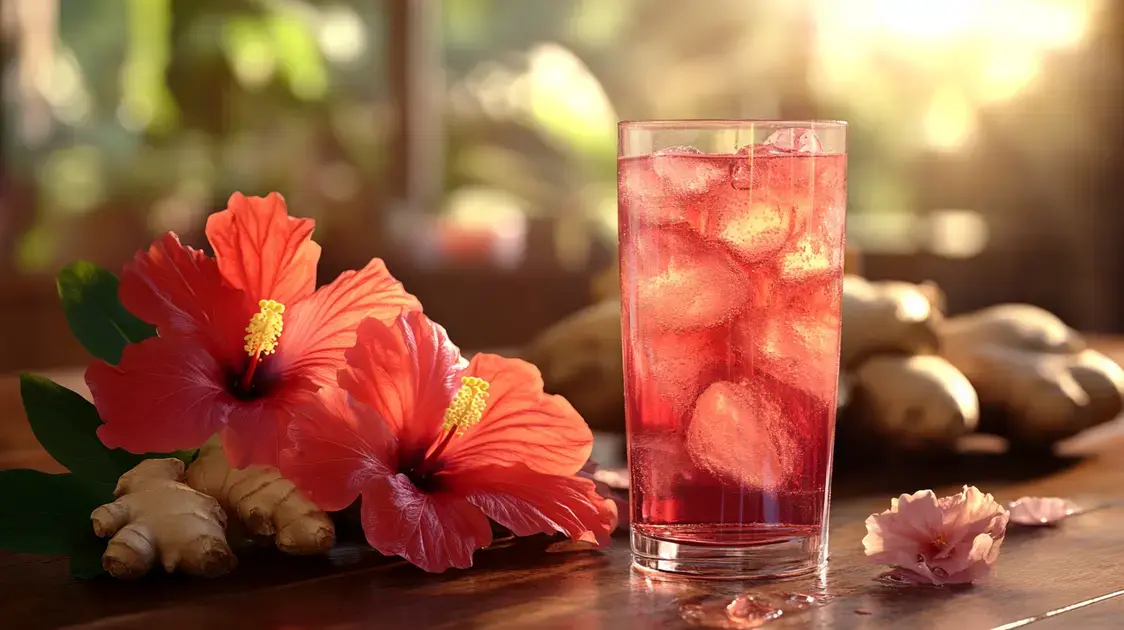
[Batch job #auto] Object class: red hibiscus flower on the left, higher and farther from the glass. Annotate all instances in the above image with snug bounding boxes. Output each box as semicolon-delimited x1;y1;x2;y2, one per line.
85;194;422;467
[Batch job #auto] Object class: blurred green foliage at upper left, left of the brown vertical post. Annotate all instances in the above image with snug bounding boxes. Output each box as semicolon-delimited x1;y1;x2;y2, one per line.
2;0;387;269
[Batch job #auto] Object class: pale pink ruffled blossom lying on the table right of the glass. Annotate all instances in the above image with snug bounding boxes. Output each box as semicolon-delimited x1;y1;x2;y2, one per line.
862;486;1009;585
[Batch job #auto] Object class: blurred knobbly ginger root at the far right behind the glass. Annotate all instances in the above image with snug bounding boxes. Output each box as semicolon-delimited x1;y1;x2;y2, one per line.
937;304;1124;446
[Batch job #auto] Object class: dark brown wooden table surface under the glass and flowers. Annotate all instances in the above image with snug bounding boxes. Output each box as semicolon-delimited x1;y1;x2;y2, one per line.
0;355;1124;630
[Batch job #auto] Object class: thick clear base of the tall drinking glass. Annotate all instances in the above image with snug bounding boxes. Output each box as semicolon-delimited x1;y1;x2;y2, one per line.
632;527;827;579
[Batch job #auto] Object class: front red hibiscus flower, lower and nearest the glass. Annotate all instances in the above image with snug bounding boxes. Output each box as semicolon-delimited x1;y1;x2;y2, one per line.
281;312;616;573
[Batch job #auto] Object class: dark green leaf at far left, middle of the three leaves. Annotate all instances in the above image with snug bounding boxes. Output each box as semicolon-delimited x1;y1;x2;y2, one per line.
19;374;145;484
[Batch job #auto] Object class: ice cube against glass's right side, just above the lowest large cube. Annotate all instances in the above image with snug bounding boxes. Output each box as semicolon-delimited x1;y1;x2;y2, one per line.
731;278;840;401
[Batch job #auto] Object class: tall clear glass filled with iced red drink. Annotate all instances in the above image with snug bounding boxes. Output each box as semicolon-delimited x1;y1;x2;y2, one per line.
617;120;846;578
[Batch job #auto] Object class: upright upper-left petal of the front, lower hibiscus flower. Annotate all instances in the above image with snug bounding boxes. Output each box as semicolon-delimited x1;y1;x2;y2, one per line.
338;311;465;459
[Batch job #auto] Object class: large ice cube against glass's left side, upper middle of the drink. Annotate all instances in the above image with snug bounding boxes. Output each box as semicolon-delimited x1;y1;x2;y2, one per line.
620;227;749;330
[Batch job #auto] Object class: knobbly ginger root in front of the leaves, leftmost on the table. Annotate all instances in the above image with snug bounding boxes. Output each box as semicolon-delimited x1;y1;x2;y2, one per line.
90;459;237;579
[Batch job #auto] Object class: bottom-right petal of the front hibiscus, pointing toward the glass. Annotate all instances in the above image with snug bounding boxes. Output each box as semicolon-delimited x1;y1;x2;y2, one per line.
438;464;616;541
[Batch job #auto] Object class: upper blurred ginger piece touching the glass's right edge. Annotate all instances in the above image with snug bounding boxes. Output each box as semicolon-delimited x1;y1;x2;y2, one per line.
840;276;941;368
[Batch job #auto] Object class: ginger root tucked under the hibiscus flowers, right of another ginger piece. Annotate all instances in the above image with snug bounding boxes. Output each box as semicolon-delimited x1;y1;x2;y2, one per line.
188;440;336;556
